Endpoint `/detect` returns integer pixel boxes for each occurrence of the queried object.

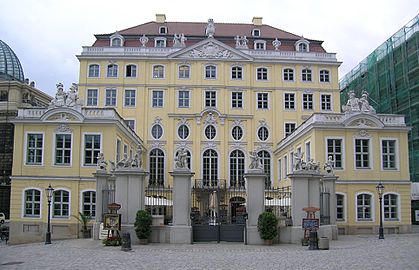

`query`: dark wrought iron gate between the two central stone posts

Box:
[191,179,246,242]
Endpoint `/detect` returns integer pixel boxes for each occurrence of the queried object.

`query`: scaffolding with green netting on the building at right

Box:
[339,15,419,182]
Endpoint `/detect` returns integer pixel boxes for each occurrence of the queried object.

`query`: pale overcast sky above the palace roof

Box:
[0,0,419,95]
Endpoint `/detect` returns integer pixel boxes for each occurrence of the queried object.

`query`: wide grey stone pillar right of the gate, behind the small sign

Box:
[288,170,322,244]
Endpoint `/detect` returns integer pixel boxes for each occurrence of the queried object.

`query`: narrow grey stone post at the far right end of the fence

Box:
[320,174,338,240]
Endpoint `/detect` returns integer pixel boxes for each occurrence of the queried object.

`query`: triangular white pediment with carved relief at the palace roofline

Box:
[169,38,252,60]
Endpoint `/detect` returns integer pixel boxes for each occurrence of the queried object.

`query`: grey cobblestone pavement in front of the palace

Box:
[0,234,419,270]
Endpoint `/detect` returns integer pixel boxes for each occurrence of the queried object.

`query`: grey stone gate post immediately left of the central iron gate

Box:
[170,170,195,244]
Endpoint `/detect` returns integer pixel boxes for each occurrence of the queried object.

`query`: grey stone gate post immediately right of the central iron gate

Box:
[244,169,266,245]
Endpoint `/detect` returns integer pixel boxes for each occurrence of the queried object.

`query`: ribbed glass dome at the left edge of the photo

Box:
[0,40,25,82]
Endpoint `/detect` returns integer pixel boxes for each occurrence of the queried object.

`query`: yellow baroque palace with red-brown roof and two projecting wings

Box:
[10,14,411,243]
